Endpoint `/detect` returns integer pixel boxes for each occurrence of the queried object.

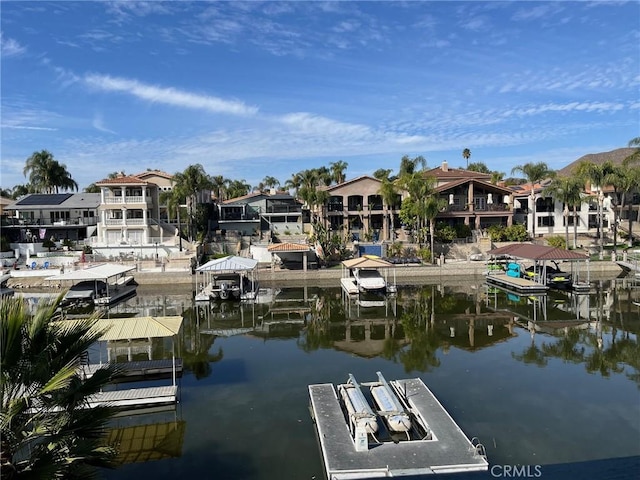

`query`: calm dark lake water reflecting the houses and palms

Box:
[47,280,640,480]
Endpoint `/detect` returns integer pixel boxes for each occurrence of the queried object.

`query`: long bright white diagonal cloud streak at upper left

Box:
[84,74,258,116]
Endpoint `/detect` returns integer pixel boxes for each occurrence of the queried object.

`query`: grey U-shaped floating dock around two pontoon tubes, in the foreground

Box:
[309,378,488,480]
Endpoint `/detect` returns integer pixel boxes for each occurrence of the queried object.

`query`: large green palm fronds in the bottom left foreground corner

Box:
[0,295,119,479]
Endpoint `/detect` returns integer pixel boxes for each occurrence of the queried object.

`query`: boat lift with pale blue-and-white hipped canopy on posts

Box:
[196,256,258,301]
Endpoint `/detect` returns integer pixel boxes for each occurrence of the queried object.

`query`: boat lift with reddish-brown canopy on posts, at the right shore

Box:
[487,243,590,292]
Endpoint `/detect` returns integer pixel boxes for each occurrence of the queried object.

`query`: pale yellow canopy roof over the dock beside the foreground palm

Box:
[95,315,182,341]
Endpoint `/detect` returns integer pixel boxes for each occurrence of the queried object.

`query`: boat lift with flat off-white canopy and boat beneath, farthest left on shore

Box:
[46,263,138,305]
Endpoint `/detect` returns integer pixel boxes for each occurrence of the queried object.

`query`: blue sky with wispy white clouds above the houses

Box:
[0,1,640,188]
